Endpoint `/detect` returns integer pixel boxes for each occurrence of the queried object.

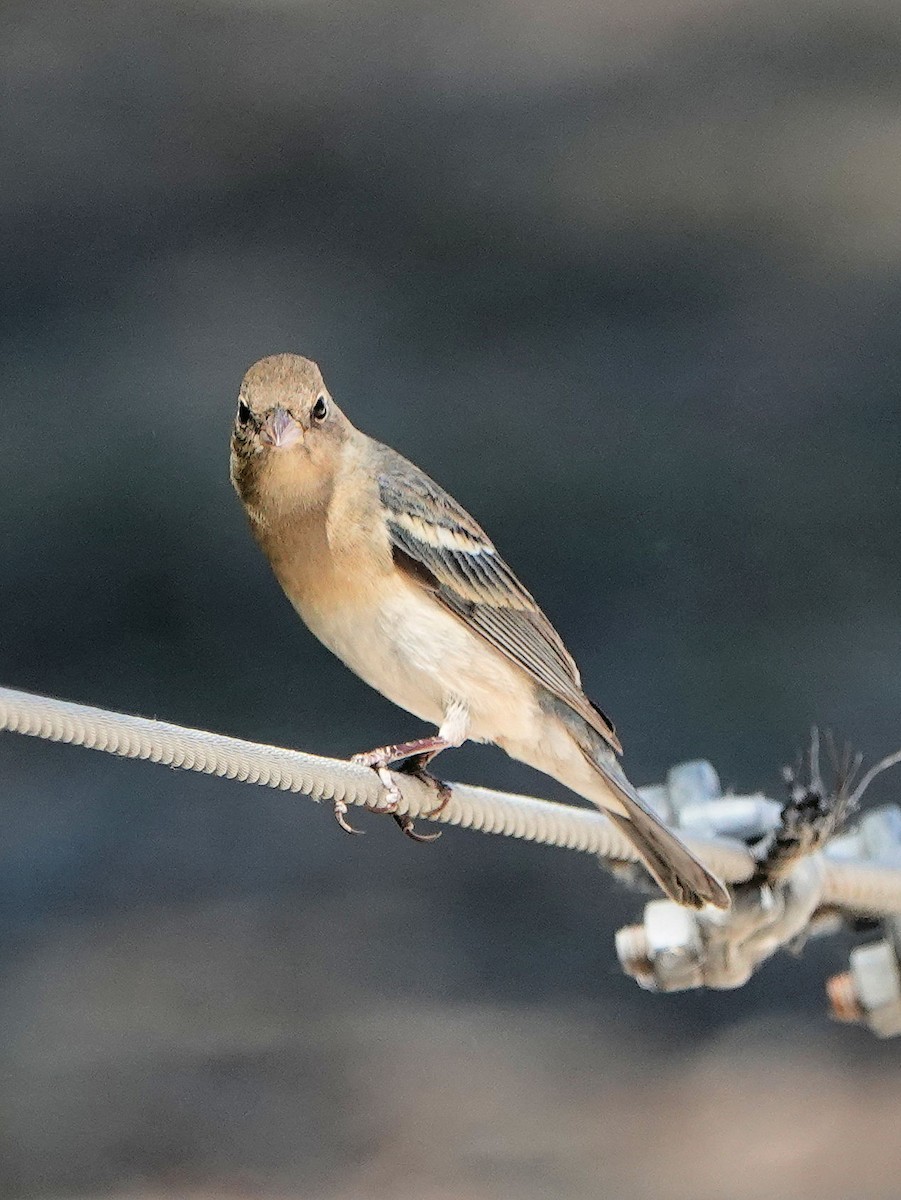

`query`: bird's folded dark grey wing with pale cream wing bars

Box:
[378,448,621,751]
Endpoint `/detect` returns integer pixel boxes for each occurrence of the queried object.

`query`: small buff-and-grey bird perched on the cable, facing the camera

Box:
[230,354,729,908]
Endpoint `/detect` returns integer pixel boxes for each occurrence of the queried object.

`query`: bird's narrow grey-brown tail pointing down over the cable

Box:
[579,739,729,908]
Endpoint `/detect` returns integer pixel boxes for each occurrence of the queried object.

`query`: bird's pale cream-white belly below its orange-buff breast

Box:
[293,583,537,742]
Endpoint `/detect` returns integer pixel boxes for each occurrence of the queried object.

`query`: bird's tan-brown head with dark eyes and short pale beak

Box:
[232,354,353,515]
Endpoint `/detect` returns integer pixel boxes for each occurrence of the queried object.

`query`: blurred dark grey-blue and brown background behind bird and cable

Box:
[0,0,901,1200]
